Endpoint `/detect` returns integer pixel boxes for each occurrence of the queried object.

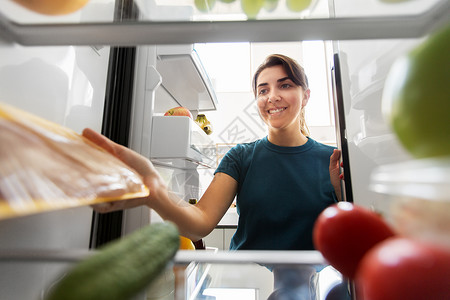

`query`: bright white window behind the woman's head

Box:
[195,41,335,144]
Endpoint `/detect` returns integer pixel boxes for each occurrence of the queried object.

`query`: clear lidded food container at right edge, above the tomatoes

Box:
[371,157,450,248]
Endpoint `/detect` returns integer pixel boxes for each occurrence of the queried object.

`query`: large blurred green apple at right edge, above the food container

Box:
[382,25,450,158]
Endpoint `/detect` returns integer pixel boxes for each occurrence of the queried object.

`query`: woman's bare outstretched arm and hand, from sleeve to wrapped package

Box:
[83,128,237,240]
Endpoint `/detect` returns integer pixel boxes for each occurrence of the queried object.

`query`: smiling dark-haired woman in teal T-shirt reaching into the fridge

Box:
[81,55,341,250]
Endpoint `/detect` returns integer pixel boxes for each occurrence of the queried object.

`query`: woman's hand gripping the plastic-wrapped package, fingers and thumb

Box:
[82,128,167,213]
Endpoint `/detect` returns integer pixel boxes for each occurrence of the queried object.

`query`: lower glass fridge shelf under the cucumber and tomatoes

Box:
[0,248,348,300]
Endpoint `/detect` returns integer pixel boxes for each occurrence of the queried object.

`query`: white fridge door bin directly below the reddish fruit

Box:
[150,116,215,169]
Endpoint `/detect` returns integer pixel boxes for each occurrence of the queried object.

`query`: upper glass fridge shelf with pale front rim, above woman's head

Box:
[0,0,450,46]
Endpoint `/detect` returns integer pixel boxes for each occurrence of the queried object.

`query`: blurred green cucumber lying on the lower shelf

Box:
[47,222,180,300]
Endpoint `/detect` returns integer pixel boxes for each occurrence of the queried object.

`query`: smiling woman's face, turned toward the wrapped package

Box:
[256,65,309,130]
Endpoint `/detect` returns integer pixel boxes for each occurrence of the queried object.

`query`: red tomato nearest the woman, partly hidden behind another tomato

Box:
[313,202,394,279]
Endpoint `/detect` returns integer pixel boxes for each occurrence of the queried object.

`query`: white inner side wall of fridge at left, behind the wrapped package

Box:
[0,40,109,299]
